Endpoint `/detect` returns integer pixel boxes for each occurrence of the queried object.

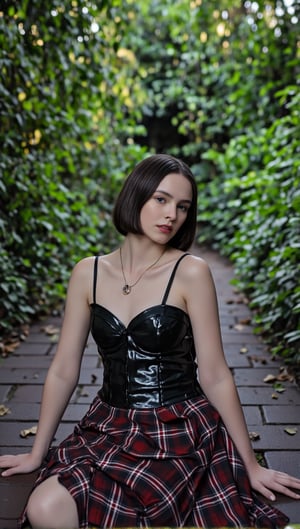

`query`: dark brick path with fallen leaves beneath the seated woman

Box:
[0,245,300,529]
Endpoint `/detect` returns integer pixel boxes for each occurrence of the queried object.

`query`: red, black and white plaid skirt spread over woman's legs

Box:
[20,396,288,529]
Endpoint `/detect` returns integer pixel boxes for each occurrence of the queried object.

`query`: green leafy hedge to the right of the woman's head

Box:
[200,87,300,361]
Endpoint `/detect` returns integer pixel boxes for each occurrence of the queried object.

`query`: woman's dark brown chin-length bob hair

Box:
[113,154,198,251]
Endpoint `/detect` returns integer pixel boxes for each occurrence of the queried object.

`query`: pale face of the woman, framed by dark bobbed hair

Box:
[140,173,192,244]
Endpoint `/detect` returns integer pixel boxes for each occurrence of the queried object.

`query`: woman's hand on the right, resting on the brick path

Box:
[249,464,300,501]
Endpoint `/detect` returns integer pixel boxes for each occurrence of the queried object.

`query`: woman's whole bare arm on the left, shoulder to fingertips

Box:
[0,259,93,476]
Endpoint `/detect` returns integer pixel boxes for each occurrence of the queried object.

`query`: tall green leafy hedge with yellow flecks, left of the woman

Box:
[0,0,143,333]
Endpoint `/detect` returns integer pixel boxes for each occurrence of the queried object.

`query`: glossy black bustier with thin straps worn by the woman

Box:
[91,254,202,408]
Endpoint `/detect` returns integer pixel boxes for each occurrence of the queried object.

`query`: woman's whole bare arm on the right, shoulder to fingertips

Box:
[186,257,300,500]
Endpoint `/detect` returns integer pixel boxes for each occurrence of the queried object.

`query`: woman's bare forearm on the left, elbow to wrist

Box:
[32,370,77,461]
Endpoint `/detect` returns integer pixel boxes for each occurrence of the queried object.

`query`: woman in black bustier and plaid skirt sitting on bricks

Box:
[0,154,300,529]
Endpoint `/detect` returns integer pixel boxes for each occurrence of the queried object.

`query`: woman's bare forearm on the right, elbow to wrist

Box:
[203,371,257,473]
